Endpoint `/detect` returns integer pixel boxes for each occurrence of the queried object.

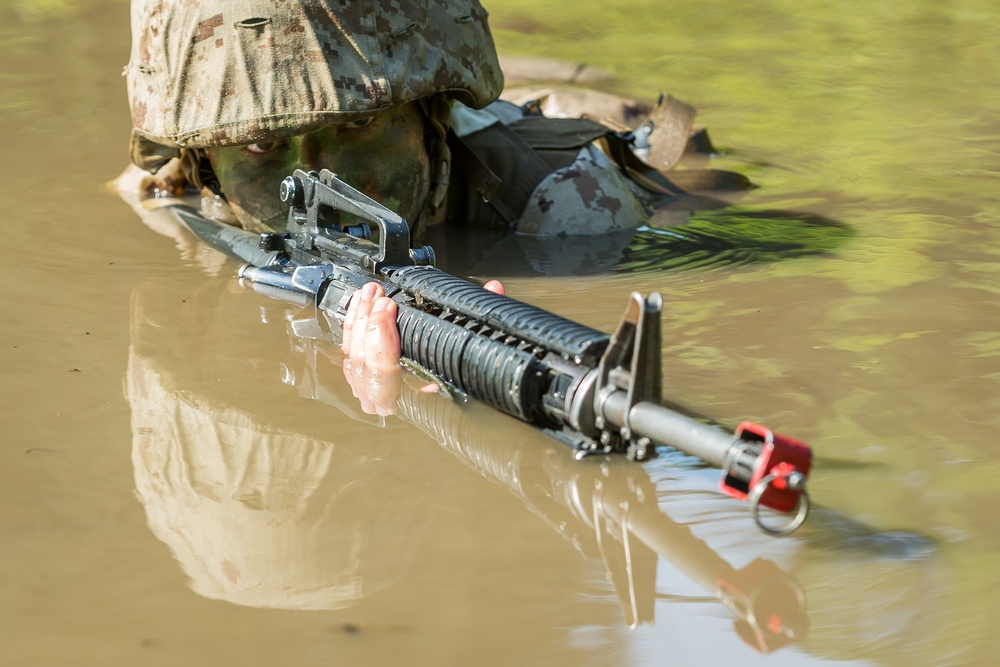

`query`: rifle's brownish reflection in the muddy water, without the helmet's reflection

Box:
[279,300,936,653]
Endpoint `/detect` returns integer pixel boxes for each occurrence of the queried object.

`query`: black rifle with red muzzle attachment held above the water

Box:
[240,170,811,534]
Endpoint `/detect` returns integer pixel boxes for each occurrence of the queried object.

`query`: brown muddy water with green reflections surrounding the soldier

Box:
[0,0,1000,665]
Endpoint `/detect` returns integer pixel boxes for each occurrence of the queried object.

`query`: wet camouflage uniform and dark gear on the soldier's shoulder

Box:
[447,102,750,236]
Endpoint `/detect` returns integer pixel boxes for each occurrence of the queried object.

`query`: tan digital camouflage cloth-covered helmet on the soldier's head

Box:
[126,0,503,170]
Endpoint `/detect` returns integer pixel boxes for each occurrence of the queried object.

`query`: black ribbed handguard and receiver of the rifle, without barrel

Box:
[242,240,610,451]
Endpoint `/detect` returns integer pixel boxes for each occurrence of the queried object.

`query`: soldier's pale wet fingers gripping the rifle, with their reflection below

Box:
[341,280,504,416]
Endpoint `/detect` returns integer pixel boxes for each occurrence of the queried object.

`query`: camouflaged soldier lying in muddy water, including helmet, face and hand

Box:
[126,0,744,402]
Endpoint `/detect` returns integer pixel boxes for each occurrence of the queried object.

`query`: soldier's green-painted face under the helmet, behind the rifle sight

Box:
[206,103,430,232]
